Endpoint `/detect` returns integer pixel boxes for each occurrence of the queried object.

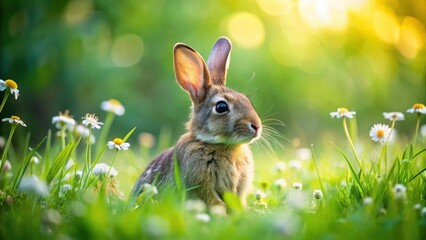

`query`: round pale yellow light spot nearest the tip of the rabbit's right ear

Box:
[227,12,265,48]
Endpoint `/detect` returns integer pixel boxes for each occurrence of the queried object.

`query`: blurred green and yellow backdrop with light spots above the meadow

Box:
[0,0,426,145]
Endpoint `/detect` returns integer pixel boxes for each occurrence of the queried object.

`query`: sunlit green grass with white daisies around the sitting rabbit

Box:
[0,79,426,239]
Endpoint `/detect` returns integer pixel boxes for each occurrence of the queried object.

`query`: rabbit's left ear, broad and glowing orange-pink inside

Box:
[173,43,211,102]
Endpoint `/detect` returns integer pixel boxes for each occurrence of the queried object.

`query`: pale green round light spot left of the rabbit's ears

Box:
[111,34,144,67]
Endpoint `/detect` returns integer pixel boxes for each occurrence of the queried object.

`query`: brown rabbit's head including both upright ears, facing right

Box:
[174,37,262,145]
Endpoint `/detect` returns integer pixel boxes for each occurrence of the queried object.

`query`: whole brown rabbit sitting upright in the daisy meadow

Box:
[132,37,262,206]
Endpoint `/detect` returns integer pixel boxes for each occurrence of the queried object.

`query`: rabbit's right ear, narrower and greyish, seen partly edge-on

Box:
[207,37,232,85]
